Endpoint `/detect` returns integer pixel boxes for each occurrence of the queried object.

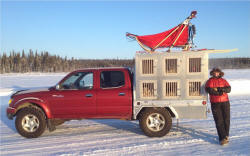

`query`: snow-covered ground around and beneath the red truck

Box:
[0,69,250,156]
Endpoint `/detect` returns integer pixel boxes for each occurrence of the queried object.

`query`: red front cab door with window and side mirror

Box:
[50,72,96,118]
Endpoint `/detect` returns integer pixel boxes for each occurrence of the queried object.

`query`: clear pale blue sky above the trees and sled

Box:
[0,0,250,59]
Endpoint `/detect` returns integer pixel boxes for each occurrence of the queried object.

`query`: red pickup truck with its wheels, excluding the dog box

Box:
[7,68,173,138]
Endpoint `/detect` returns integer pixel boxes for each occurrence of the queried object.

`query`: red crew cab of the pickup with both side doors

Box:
[48,68,133,119]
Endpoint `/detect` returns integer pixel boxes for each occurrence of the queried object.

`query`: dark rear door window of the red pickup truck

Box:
[100,71,125,88]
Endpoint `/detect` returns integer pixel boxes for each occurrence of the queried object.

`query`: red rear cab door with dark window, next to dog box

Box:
[97,70,132,118]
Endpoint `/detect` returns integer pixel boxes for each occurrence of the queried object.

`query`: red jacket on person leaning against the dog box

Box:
[206,77,231,103]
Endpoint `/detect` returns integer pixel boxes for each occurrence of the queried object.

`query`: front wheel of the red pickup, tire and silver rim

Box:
[15,107,46,138]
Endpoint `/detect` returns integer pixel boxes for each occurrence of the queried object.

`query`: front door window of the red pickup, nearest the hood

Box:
[60,72,93,89]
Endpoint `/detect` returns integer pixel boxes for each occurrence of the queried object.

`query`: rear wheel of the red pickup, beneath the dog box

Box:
[139,108,172,137]
